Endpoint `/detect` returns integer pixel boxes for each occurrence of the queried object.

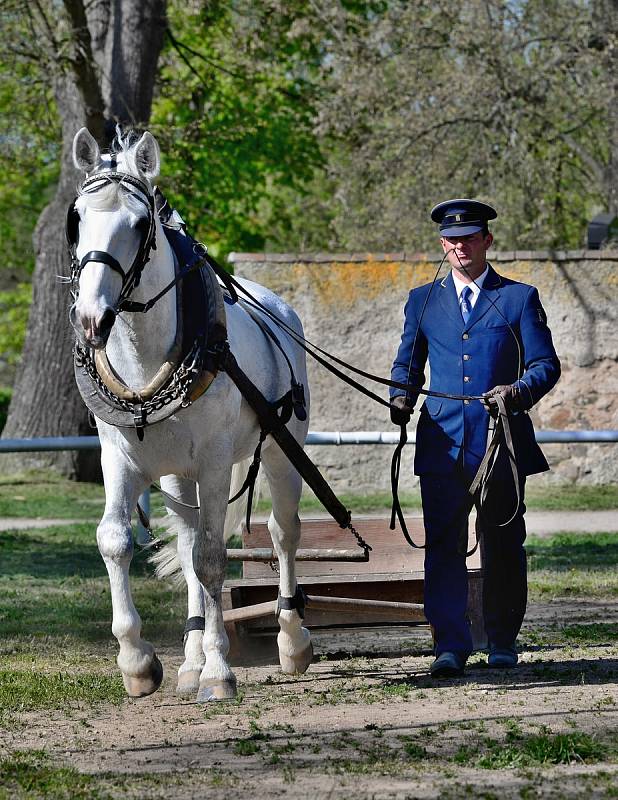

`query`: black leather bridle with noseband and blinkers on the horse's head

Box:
[66,172,156,311]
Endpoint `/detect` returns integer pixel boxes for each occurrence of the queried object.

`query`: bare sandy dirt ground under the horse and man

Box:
[0,601,618,800]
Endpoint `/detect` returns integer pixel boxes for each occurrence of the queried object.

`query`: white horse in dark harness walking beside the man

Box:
[70,128,312,702]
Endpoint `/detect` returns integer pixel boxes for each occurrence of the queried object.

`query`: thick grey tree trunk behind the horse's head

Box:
[2,0,165,480]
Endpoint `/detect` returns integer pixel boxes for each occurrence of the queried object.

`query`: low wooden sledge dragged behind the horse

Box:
[223,516,487,665]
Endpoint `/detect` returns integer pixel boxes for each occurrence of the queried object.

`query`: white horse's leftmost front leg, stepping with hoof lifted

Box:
[97,444,163,697]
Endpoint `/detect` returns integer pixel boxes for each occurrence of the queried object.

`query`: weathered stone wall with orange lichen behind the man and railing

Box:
[230,251,618,492]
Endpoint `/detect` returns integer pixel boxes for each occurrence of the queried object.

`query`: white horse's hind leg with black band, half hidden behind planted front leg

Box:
[161,475,204,697]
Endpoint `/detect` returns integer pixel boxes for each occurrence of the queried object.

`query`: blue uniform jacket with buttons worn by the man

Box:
[390,266,560,475]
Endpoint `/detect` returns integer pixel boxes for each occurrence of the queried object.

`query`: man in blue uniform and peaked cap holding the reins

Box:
[391,200,560,677]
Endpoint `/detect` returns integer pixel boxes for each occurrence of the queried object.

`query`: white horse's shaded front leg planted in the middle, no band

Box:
[193,453,236,703]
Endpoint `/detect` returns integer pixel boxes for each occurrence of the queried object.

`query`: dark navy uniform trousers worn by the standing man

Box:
[420,460,527,660]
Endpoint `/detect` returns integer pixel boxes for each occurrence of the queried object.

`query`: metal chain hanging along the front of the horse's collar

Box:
[75,340,202,416]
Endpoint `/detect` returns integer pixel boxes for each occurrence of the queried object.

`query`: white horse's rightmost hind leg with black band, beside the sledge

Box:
[263,443,313,674]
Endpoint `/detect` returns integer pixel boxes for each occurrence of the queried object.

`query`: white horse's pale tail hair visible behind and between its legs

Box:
[148,458,260,586]
